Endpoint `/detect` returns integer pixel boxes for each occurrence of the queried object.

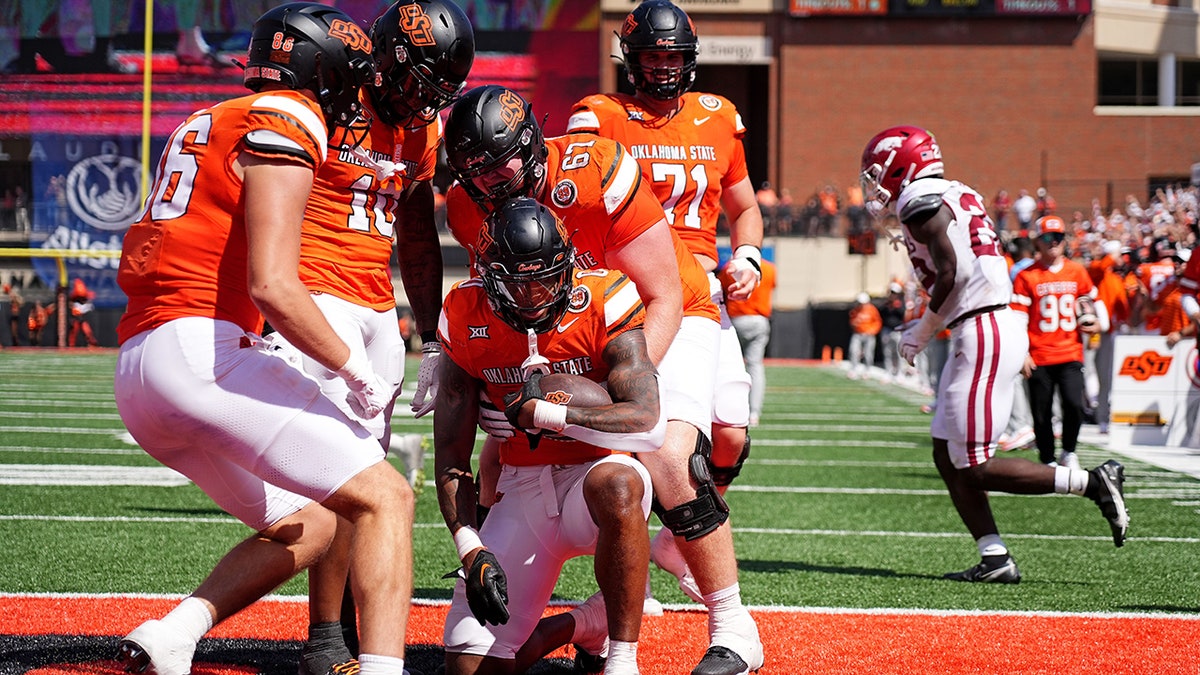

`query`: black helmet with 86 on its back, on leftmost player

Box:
[242,2,374,144]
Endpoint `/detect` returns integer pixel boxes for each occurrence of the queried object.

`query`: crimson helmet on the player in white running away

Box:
[860,126,944,217]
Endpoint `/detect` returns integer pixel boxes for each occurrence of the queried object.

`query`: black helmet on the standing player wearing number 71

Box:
[617,0,700,101]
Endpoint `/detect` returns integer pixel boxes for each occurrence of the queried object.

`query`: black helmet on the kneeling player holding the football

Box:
[475,197,575,333]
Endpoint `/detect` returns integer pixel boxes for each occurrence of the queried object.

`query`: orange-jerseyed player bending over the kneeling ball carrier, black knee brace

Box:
[445,85,762,674]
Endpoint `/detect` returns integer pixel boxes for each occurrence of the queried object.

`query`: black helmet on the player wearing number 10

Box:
[367,0,475,127]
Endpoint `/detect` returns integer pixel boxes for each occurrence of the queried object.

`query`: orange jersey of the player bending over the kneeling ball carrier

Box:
[446,133,720,321]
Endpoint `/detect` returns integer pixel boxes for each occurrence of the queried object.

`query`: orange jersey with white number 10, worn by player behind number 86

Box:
[300,94,442,311]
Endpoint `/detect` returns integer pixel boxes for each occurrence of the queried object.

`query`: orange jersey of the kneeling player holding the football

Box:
[438,269,646,466]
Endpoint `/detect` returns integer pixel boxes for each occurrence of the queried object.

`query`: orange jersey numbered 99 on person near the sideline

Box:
[1012,259,1096,365]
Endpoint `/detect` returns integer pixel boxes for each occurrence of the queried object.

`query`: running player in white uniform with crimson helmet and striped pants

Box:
[862,126,1129,584]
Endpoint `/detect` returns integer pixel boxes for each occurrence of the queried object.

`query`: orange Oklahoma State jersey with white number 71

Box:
[566,91,748,261]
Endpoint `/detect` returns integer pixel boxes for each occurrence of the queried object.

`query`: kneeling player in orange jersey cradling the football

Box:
[433,198,666,675]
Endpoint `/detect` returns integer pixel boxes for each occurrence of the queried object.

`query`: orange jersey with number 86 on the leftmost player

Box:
[116,91,328,342]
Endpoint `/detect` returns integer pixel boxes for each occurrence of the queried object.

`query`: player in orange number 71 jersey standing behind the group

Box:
[568,0,762,619]
